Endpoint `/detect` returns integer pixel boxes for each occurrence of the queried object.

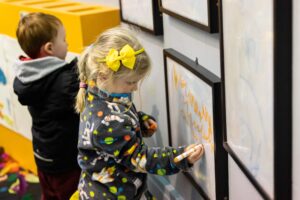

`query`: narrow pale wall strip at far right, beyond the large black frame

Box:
[293,0,300,200]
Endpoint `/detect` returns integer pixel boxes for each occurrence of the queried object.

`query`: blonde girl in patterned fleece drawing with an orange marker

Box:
[76,28,203,199]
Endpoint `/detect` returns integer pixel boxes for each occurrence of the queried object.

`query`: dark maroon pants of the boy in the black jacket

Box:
[38,169,81,200]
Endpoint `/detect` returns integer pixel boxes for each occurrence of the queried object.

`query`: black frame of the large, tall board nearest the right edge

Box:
[219,0,292,199]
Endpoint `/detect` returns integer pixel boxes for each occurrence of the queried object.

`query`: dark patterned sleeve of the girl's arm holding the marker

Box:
[92,108,189,175]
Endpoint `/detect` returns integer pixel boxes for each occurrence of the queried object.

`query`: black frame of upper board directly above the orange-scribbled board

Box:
[160,0,219,33]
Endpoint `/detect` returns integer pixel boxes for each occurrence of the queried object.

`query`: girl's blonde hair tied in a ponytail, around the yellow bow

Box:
[75,27,150,112]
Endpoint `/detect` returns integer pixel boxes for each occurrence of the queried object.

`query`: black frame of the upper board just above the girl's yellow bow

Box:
[119,0,163,35]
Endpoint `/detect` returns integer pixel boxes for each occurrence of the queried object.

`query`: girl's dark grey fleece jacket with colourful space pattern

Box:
[78,85,189,200]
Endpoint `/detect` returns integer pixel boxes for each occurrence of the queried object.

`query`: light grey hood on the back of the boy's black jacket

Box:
[13,56,67,84]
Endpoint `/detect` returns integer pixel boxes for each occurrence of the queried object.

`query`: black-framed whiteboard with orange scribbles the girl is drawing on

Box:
[164,49,227,199]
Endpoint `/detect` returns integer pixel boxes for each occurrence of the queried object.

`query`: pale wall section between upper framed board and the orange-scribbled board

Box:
[163,14,221,77]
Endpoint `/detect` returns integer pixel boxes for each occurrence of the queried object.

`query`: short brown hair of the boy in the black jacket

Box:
[16,12,62,59]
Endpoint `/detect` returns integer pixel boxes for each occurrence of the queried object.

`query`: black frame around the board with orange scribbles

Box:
[163,49,228,199]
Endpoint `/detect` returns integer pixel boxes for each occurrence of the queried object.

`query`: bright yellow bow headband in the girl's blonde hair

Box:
[99,44,144,72]
